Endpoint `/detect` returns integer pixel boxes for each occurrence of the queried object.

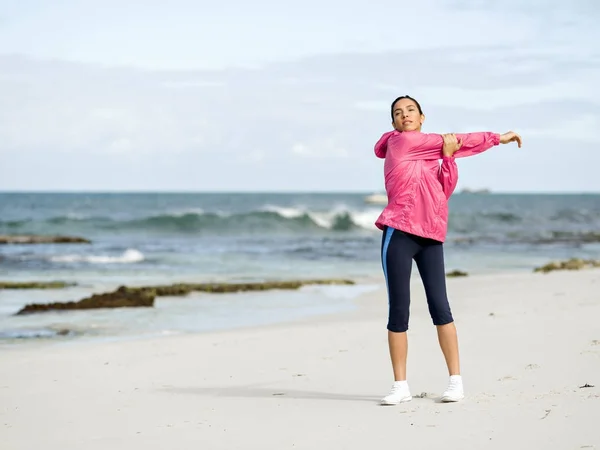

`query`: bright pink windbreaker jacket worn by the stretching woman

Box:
[375,130,500,242]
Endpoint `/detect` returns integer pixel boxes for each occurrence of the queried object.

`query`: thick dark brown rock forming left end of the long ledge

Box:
[17,286,155,315]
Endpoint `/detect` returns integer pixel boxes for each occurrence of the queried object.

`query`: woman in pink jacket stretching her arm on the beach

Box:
[375,96,521,405]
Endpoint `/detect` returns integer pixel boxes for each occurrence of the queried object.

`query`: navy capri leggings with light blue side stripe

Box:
[381,227,454,333]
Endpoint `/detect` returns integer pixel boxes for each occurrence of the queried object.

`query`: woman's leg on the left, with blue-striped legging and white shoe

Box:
[381,228,420,405]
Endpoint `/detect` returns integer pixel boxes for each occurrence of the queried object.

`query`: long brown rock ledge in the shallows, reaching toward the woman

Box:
[11,279,354,315]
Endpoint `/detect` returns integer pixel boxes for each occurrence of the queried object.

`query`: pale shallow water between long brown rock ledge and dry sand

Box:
[0,279,377,350]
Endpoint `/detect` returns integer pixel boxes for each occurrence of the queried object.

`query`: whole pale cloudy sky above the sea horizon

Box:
[0,0,600,192]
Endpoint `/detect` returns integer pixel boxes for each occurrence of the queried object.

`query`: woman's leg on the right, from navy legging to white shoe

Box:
[415,240,463,401]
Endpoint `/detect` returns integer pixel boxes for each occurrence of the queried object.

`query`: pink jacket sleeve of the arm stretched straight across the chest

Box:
[398,131,500,161]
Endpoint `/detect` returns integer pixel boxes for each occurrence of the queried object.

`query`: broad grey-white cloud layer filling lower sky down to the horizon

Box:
[0,32,600,191]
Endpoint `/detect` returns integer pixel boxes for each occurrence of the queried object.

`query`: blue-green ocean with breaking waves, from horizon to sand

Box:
[0,193,600,342]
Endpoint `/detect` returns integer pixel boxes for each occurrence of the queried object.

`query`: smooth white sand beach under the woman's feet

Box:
[0,270,600,450]
